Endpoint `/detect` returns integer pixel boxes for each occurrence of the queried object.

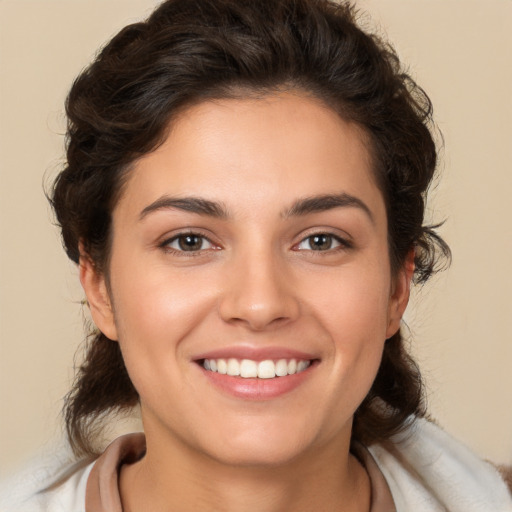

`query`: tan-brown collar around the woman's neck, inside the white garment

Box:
[85,433,396,512]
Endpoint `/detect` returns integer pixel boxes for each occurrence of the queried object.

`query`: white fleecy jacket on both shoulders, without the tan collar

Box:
[0,419,512,512]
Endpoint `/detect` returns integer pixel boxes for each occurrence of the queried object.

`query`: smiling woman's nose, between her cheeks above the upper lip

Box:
[219,250,300,331]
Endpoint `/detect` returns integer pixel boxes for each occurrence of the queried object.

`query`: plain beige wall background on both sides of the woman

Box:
[0,0,512,474]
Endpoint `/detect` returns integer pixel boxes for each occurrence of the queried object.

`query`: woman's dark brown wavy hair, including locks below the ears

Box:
[49,0,450,454]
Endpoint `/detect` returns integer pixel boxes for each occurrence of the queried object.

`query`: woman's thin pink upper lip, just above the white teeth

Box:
[192,345,318,361]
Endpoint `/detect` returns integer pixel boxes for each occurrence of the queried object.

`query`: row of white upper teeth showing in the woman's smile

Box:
[203,358,311,379]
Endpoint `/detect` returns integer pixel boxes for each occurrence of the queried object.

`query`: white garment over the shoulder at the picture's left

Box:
[0,443,94,512]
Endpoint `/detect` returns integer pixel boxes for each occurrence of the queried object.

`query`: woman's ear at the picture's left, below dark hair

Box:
[79,244,117,340]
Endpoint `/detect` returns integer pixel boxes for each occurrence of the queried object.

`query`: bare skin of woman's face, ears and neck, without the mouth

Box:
[80,92,412,512]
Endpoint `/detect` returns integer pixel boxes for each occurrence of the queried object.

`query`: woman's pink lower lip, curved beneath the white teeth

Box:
[199,361,317,400]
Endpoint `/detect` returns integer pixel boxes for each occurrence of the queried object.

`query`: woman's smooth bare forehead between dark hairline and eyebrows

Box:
[118,93,382,222]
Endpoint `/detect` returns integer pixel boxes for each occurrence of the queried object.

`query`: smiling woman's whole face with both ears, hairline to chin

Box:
[81,93,410,464]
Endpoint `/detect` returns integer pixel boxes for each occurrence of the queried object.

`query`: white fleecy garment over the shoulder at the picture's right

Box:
[369,419,512,512]
